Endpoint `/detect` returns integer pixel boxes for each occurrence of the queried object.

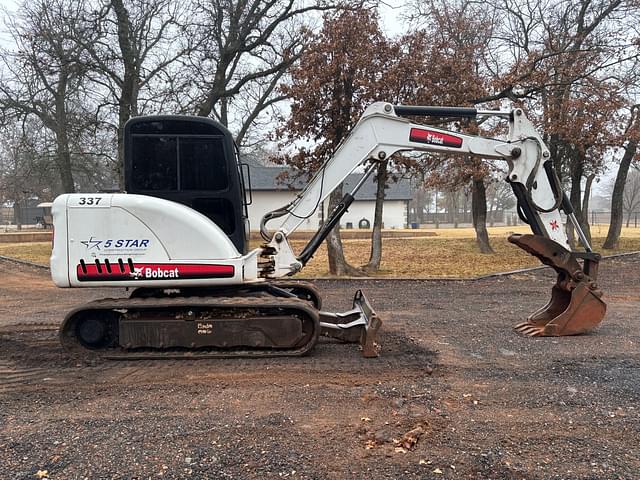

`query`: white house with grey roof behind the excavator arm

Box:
[249,165,411,230]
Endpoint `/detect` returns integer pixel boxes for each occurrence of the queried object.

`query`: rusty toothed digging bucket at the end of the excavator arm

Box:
[509,234,607,337]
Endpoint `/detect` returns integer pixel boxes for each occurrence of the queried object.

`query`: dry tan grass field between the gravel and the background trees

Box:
[0,225,640,278]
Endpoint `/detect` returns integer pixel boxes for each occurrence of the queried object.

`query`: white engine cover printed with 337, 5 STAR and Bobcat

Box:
[51,193,258,288]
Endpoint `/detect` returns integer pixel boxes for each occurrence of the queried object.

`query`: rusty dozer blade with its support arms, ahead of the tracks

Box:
[320,290,382,358]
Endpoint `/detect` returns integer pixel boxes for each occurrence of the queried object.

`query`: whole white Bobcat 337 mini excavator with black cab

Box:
[51,102,606,359]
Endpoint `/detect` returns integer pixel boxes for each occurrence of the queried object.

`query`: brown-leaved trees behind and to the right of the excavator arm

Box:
[280,0,640,274]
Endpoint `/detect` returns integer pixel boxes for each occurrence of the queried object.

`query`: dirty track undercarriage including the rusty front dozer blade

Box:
[60,282,381,359]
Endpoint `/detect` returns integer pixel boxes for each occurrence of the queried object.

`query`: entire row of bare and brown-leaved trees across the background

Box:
[0,0,640,274]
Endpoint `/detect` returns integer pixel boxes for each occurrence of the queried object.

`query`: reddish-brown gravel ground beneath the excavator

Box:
[0,256,640,479]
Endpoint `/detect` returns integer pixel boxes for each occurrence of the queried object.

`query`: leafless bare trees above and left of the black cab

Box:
[0,0,344,195]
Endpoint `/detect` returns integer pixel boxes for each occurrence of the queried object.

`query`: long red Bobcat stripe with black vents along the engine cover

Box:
[76,262,235,282]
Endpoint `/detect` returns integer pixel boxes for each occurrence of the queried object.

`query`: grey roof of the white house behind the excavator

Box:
[245,165,411,200]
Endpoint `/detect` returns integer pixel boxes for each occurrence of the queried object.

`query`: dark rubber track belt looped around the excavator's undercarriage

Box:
[60,297,320,360]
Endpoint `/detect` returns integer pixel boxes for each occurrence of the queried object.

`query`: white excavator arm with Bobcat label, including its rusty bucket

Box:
[261,102,605,335]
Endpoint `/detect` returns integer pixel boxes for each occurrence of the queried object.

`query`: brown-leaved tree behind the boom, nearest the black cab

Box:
[280,9,390,275]
